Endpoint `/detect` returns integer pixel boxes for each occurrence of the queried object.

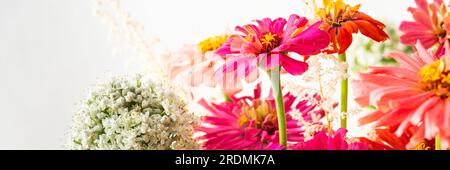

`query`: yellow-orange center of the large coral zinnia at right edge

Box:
[418,60,450,99]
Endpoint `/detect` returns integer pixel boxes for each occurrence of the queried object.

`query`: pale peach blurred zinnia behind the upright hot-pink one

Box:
[168,35,242,95]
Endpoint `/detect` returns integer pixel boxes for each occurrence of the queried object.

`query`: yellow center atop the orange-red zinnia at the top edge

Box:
[313,0,361,27]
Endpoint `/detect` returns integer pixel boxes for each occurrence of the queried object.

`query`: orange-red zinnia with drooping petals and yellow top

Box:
[314,0,389,54]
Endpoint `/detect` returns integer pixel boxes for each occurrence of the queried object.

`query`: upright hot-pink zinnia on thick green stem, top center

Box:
[216,15,329,82]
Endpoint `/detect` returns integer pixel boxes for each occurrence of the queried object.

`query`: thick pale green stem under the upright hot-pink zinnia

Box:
[268,67,287,147]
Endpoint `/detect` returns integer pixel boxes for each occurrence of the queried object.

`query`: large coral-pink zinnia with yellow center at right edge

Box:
[354,42,450,149]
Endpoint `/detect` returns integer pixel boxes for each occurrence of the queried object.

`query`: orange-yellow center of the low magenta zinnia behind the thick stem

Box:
[239,100,277,133]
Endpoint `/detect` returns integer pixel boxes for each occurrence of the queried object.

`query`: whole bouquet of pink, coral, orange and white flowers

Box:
[68,0,450,150]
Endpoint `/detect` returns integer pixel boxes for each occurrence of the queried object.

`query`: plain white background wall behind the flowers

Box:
[0,0,414,149]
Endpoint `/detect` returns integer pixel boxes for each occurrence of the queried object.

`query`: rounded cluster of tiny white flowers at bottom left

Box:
[68,76,199,150]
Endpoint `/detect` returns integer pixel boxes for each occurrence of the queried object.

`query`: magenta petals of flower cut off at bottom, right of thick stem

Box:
[291,128,369,150]
